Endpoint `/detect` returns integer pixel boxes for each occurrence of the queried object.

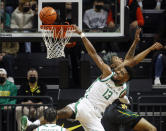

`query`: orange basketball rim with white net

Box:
[40,25,74,59]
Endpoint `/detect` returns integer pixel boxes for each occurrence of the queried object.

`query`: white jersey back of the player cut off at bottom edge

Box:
[36,124,66,131]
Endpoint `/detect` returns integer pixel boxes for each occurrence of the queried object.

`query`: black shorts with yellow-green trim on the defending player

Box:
[102,100,141,131]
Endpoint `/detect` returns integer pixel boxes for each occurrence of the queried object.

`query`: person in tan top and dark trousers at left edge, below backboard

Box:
[0,42,19,83]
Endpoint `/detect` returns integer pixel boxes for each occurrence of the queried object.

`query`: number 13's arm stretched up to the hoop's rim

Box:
[75,26,111,74]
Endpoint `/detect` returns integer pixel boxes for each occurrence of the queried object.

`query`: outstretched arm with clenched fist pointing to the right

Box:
[116,42,163,69]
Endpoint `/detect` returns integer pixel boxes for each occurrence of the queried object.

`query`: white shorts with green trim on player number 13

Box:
[68,98,104,131]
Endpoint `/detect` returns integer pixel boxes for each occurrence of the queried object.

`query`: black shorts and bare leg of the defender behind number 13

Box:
[102,99,157,131]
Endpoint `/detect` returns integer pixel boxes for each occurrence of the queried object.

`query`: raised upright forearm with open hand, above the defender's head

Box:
[125,28,141,60]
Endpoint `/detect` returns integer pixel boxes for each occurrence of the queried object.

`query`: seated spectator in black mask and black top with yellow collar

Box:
[16,68,47,131]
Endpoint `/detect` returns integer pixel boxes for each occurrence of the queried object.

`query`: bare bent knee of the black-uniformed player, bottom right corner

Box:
[133,118,157,131]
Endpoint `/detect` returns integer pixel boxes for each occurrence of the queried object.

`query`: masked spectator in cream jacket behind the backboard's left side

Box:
[10,0,35,53]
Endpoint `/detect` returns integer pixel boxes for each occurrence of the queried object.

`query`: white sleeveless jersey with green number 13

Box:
[85,73,127,113]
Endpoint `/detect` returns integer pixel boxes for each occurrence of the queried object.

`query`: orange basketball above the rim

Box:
[39,7,57,25]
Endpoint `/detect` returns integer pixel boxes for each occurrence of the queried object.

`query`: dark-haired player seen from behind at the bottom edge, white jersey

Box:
[22,107,69,131]
